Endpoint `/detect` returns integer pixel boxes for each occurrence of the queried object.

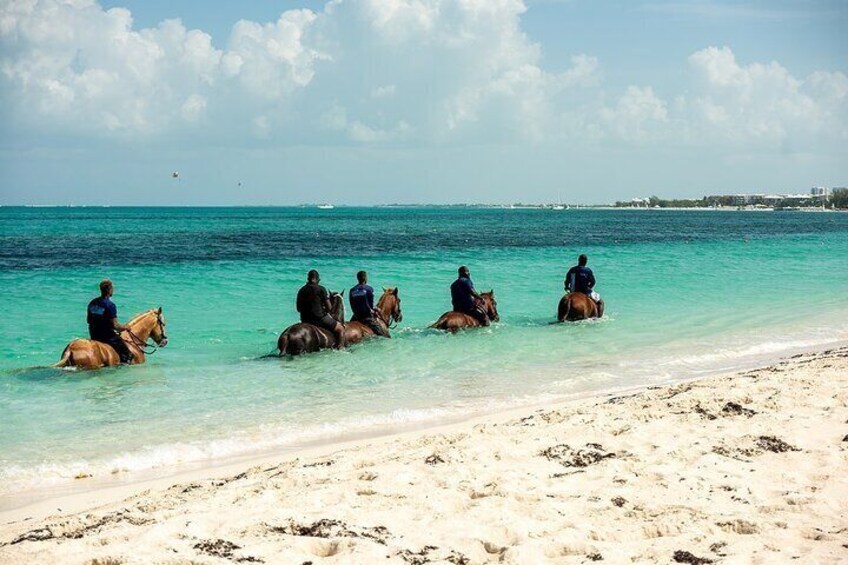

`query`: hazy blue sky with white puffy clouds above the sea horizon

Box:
[0,0,848,206]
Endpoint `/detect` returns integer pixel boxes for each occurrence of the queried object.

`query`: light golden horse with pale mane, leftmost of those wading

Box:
[53,306,168,369]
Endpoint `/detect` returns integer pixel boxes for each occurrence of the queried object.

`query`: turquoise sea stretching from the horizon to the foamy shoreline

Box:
[0,208,848,498]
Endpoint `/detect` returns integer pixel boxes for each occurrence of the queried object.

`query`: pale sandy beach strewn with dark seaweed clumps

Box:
[0,348,848,565]
